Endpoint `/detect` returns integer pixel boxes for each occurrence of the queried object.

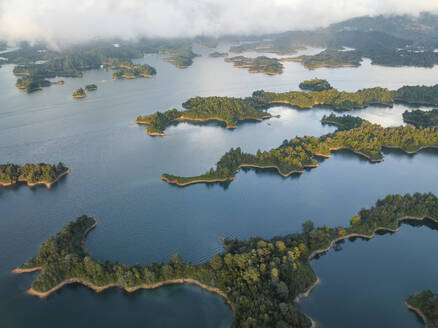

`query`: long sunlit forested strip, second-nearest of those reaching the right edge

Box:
[139,79,438,136]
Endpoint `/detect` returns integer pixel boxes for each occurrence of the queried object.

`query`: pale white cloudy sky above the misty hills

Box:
[0,0,438,43]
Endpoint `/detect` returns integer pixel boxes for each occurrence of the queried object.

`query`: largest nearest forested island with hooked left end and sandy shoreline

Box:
[13,193,438,328]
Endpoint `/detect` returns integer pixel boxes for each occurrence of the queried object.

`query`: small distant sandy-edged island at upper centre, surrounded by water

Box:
[224,56,284,75]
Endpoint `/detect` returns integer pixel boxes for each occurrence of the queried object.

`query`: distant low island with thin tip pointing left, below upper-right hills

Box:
[283,49,362,69]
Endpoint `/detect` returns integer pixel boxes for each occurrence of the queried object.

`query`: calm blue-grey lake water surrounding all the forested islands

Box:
[0,45,438,328]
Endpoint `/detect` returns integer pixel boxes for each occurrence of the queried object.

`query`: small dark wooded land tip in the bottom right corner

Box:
[405,290,438,328]
